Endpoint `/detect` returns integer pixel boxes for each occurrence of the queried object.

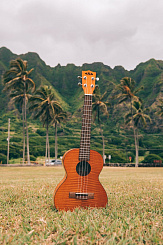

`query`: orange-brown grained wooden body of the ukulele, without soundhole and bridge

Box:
[54,149,107,211]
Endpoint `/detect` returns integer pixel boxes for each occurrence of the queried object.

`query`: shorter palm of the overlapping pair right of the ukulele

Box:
[125,101,151,167]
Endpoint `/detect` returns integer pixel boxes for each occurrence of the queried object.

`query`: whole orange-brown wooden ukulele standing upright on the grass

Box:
[54,71,107,211]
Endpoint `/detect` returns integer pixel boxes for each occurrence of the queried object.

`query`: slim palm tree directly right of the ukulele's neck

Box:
[92,88,110,162]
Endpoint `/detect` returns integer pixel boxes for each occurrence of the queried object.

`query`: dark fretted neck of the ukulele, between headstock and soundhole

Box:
[79,95,92,161]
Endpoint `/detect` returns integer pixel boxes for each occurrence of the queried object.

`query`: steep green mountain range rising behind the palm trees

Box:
[0,47,163,164]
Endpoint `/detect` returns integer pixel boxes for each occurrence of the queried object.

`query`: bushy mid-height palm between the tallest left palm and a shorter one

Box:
[29,86,62,163]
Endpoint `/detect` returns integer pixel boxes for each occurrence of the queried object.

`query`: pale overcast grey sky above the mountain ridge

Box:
[0,0,163,70]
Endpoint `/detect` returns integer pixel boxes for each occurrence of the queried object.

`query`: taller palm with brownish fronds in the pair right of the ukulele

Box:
[117,77,143,167]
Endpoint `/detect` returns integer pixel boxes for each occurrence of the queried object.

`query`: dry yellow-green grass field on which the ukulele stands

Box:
[0,167,163,244]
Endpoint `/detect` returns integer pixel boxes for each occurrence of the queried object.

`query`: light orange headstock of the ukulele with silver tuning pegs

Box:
[78,71,99,95]
